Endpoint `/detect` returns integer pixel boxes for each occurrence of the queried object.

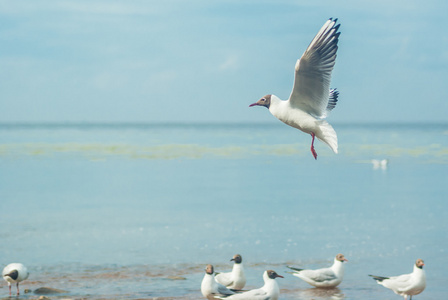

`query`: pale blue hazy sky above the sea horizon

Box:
[0,0,448,123]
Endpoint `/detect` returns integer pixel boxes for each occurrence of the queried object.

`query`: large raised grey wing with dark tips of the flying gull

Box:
[289,19,341,118]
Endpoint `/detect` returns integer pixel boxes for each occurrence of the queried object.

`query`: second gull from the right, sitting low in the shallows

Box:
[288,254,348,288]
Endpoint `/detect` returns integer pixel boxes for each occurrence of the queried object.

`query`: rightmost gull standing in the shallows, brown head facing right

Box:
[369,259,426,300]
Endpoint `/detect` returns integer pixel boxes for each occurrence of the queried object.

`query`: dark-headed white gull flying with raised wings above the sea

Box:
[249,19,341,159]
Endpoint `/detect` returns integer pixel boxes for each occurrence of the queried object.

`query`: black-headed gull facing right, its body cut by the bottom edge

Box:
[215,270,283,300]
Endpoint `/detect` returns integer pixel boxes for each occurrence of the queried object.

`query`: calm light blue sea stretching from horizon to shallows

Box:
[0,124,448,300]
